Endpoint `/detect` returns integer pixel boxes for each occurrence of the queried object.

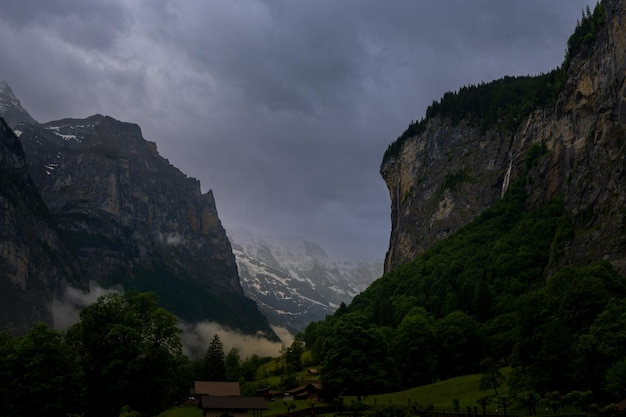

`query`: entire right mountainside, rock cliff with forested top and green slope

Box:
[305,0,626,400]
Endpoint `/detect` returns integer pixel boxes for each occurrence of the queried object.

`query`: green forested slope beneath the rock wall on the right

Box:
[304,141,626,404]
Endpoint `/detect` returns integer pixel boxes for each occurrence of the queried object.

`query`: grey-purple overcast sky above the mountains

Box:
[0,0,595,259]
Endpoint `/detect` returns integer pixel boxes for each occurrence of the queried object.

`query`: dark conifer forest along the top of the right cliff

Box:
[383,3,604,163]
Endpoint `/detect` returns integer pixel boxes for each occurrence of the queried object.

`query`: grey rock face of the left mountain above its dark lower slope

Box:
[18,115,242,294]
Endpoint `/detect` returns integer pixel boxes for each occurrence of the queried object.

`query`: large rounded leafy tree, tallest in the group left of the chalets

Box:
[68,293,185,416]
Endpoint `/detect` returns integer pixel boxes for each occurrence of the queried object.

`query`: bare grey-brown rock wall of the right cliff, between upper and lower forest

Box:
[381,0,626,273]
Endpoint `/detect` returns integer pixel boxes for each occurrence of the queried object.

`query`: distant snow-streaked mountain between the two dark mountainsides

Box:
[227,228,383,332]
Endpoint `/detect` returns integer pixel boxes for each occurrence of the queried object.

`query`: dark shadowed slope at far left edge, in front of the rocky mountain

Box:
[0,119,87,334]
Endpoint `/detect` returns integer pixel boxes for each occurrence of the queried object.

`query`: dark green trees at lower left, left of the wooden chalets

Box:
[0,292,276,417]
